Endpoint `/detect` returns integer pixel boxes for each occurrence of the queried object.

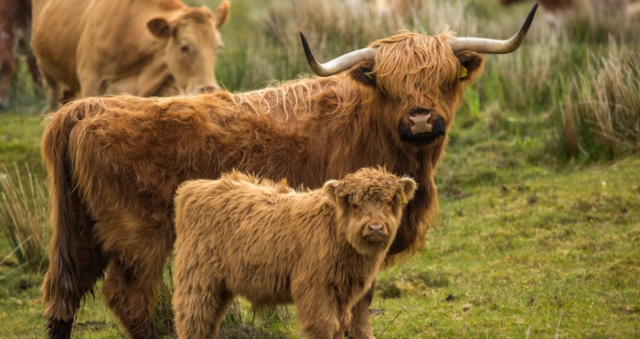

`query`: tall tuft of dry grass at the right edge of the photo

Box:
[561,40,640,159]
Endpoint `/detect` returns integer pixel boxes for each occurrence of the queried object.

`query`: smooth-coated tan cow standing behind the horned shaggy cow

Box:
[31,0,229,110]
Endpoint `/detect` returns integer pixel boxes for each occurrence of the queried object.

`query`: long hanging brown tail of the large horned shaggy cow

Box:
[41,101,86,321]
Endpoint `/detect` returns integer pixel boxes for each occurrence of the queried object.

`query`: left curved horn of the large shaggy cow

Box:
[300,32,376,77]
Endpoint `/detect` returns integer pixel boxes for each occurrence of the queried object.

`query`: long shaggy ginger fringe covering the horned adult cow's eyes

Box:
[369,31,459,107]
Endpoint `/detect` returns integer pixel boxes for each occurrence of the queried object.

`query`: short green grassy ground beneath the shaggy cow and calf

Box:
[0,143,640,338]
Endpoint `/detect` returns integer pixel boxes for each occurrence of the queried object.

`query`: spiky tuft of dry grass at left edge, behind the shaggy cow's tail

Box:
[0,164,51,273]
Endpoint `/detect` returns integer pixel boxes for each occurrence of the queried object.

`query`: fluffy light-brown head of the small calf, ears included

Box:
[324,169,416,255]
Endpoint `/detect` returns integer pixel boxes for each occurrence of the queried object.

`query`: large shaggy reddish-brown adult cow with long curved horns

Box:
[42,7,534,338]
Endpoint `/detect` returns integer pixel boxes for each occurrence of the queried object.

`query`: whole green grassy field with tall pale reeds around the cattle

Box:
[0,0,640,338]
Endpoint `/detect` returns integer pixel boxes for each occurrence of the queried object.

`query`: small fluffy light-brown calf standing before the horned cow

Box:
[173,168,416,339]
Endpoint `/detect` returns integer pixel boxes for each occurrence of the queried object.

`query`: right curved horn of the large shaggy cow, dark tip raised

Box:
[448,4,538,54]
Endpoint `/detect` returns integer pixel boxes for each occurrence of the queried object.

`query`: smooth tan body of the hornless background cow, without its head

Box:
[31,0,185,94]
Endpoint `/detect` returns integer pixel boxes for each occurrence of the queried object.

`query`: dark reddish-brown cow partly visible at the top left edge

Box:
[0,0,42,108]
